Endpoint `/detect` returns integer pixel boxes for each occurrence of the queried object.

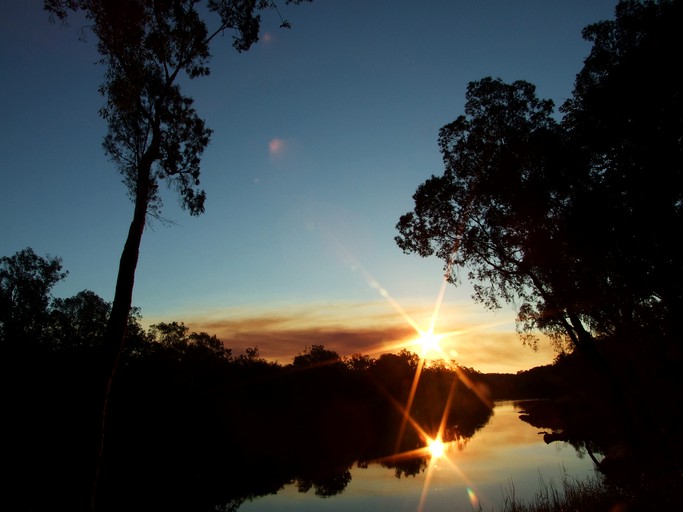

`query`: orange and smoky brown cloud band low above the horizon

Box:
[186,301,554,373]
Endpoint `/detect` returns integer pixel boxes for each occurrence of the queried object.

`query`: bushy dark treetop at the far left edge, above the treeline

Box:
[0,247,67,347]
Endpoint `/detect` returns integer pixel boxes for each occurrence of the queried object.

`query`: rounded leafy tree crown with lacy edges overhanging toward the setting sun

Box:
[396,78,585,345]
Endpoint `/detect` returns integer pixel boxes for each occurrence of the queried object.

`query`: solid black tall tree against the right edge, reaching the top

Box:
[561,0,683,346]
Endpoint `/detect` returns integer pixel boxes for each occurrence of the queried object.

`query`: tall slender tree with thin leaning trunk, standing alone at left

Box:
[44,0,310,508]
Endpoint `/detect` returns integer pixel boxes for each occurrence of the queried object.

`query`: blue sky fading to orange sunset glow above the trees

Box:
[0,0,616,372]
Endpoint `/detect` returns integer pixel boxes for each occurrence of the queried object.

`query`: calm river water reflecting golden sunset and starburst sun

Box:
[239,401,594,512]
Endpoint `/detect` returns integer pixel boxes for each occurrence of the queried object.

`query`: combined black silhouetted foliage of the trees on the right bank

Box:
[396,1,683,358]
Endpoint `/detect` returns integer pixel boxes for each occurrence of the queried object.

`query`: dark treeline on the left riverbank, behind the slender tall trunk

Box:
[0,249,491,511]
